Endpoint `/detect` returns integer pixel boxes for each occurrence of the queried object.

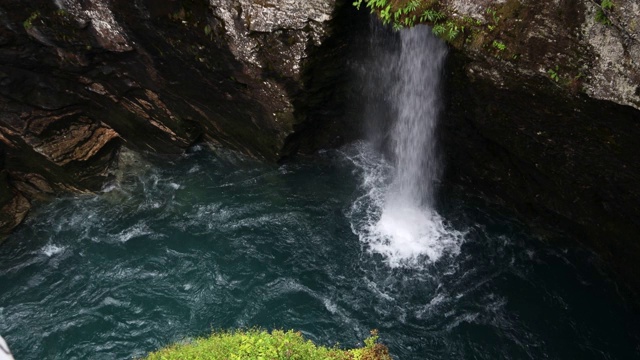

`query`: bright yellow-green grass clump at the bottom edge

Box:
[145,329,391,360]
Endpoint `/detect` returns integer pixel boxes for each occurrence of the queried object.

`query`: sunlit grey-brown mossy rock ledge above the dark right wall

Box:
[440,0,640,109]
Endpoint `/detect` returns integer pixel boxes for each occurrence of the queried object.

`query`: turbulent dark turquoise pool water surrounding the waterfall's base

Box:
[0,144,640,359]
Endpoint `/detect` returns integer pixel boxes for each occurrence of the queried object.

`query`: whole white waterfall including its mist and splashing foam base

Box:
[352,26,462,266]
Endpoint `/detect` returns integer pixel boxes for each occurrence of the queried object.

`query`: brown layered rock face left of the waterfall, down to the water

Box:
[0,0,344,238]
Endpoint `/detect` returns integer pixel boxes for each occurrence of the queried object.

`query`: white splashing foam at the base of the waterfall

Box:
[345,142,464,268]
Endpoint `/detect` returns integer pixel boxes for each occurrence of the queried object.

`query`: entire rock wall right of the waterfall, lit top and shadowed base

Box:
[442,0,640,301]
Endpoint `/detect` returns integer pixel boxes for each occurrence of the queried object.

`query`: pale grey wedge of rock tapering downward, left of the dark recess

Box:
[209,0,336,148]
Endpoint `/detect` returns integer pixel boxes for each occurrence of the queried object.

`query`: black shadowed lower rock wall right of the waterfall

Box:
[441,51,640,295]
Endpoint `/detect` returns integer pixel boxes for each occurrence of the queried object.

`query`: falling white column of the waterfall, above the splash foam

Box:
[387,27,446,208]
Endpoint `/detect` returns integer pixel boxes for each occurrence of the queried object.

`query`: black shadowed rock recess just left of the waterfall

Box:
[282,3,371,160]
